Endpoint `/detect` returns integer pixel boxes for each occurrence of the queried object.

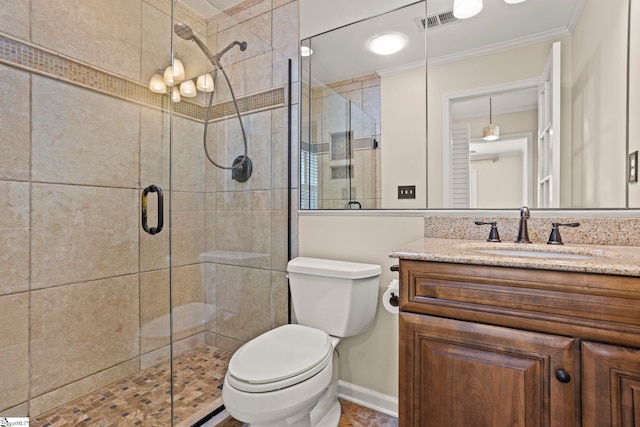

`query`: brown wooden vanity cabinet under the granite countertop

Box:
[399,259,640,427]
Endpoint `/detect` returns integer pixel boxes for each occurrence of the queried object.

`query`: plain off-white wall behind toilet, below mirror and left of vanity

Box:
[298,216,424,397]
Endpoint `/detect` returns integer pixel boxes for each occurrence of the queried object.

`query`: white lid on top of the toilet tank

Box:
[287,257,382,279]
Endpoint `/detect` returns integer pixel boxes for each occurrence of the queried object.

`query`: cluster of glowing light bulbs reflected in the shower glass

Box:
[149,58,214,102]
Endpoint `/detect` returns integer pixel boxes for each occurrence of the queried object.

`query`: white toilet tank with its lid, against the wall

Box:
[287,257,382,338]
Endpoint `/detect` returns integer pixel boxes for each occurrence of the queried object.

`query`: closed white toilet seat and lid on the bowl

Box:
[226,325,333,393]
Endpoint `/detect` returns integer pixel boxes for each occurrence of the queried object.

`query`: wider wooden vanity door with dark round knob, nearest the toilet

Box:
[399,313,577,427]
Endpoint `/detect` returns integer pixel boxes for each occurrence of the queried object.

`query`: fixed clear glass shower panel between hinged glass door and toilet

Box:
[170,0,298,426]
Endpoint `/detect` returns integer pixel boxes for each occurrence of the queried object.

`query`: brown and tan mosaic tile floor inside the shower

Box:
[30,345,231,427]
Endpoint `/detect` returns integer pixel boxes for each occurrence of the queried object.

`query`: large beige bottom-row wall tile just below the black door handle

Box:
[30,275,139,396]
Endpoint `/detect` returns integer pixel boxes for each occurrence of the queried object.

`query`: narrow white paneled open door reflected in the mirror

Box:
[538,42,561,208]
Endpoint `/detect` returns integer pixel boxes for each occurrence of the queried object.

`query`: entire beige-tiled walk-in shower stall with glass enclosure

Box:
[0,0,298,426]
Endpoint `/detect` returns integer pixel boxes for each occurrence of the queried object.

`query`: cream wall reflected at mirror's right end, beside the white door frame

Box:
[571,0,637,208]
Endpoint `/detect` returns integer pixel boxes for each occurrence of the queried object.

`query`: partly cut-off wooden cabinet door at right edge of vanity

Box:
[582,342,640,427]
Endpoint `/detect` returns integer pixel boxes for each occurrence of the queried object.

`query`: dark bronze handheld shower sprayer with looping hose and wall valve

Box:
[173,22,253,182]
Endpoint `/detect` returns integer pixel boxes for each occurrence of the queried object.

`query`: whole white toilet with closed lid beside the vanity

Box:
[222,257,382,427]
